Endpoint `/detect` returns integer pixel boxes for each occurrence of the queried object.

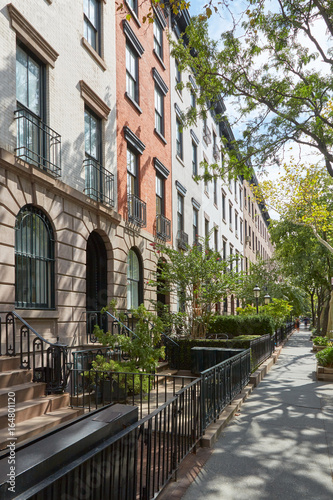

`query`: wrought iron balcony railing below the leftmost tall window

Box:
[15,108,61,177]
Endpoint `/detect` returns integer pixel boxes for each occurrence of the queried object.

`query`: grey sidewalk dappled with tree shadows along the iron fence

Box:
[162,327,333,500]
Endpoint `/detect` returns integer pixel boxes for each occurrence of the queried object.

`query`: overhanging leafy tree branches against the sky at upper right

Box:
[173,0,333,176]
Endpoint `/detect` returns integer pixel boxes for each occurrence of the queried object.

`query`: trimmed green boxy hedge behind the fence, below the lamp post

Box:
[208,314,274,338]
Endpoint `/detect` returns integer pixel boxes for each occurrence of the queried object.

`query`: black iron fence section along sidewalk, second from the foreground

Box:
[201,349,251,432]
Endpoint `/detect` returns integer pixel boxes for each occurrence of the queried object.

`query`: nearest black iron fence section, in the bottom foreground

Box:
[25,379,201,500]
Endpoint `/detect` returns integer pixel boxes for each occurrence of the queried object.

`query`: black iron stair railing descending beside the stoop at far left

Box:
[0,311,69,393]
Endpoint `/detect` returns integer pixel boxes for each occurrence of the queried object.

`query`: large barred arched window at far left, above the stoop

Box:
[15,205,54,309]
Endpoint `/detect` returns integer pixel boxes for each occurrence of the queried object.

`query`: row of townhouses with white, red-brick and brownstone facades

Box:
[0,0,270,360]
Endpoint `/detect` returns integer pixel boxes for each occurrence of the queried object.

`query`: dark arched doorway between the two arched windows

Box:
[86,231,108,334]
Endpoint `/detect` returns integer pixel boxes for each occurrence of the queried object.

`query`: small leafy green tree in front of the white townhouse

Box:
[149,237,239,338]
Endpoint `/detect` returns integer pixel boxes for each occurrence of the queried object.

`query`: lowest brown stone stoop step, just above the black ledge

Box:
[0,408,83,450]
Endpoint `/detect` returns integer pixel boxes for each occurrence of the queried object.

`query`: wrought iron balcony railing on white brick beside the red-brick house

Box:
[83,158,114,207]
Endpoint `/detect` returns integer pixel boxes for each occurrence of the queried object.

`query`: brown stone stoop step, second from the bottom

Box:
[0,393,69,429]
